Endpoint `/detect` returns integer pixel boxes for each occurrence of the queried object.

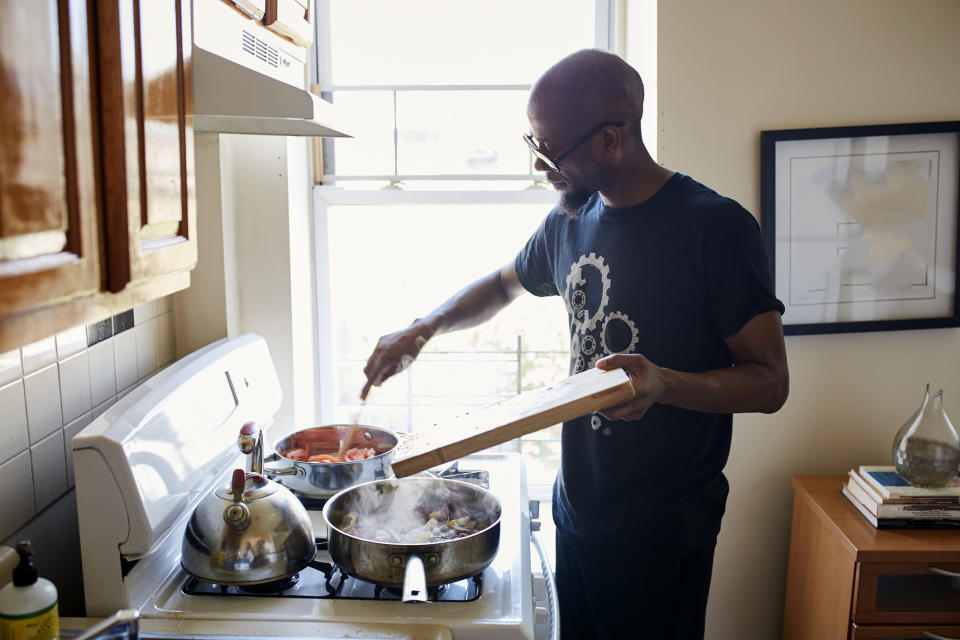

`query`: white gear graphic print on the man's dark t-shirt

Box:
[563,253,640,436]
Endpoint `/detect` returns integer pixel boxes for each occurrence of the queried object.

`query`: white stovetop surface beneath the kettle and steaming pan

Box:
[125,454,534,640]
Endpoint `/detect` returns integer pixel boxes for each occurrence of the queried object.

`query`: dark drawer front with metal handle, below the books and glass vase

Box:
[853,562,960,625]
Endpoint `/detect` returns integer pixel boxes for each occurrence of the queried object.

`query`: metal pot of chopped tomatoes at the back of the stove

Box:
[254,425,399,499]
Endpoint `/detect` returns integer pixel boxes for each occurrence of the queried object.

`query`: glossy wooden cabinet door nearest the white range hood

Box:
[95,0,197,292]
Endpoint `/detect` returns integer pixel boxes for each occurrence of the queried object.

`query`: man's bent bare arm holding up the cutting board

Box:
[597,311,790,420]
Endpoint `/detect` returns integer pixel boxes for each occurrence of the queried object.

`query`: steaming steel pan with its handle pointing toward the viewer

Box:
[323,477,501,602]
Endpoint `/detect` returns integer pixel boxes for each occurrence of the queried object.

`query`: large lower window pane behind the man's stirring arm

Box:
[328,205,569,436]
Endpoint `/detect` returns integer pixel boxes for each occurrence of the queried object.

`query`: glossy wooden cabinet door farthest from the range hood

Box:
[0,0,100,317]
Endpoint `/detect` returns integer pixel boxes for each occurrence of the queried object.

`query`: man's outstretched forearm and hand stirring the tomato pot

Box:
[360,262,524,399]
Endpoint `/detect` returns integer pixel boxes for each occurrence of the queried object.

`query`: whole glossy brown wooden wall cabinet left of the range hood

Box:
[0,0,197,351]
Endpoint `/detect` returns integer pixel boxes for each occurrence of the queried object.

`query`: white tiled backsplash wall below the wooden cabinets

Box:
[0,298,175,615]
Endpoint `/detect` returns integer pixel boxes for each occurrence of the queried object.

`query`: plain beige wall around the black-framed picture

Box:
[657,0,960,640]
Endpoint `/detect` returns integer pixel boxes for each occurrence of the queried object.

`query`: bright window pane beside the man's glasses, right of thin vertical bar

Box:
[397,91,530,175]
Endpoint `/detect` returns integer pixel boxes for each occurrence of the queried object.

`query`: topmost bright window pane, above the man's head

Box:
[330,0,595,85]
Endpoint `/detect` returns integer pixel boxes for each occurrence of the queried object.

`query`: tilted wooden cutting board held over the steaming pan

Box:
[392,369,633,478]
